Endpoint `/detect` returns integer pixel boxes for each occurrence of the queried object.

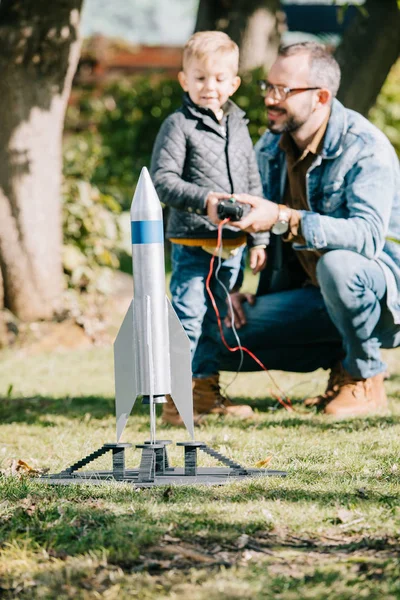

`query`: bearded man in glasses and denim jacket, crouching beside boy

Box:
[216,42,400,417]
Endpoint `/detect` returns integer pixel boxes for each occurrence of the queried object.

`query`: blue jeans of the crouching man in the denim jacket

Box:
[221,250,400,378]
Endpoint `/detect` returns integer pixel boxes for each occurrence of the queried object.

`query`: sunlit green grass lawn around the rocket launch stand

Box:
[0,340,400,600]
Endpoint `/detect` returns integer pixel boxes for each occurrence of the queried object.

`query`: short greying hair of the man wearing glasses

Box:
[278,42,340,97]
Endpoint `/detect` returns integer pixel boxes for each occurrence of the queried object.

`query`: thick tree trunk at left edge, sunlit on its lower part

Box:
[0,0,83,320]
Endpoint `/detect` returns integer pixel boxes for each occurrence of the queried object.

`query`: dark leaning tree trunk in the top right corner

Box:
[336,0,400,115]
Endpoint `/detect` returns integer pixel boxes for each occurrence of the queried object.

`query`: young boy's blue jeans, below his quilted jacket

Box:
[170,244,243,377]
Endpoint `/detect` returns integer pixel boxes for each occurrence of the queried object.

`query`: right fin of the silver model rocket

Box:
[166,297,194,439]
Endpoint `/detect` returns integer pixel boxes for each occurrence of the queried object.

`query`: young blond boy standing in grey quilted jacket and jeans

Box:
[151,31,268,425]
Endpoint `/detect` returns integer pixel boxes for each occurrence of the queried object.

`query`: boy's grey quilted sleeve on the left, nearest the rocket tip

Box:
[150,113,211,215]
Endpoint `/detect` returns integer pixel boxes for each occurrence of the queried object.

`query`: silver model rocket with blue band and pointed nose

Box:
[114,168,193,442]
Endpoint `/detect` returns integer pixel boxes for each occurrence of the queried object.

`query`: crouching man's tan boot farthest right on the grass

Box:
[324,370,387,417]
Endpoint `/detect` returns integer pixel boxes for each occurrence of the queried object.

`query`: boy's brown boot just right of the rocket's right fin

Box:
[193,374,254,419]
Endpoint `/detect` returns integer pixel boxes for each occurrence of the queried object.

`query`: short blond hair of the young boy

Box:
[183,31,239,74]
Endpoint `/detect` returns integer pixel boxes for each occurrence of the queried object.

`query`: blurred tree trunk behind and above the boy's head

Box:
[195,0,284,72]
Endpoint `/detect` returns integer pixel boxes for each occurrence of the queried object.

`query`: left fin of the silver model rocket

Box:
[114,300,139,442]
